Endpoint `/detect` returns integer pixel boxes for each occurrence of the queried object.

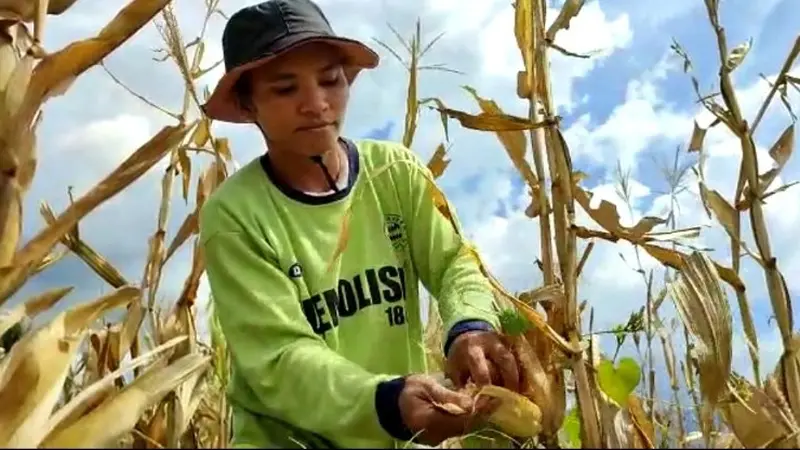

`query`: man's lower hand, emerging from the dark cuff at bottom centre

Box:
[400,374,497,446]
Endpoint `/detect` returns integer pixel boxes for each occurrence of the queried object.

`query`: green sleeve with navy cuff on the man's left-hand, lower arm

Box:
[201,206,410,445]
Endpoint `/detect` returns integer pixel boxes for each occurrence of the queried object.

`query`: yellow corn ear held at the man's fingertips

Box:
[478,385,542,438]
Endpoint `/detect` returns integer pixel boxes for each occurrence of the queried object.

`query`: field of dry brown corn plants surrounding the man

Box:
[0,0,800,448]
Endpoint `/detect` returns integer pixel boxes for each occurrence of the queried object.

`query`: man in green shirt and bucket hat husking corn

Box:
[200,0,520,448]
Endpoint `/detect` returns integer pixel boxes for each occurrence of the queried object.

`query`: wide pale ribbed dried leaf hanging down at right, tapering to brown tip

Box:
[668,252,733,407]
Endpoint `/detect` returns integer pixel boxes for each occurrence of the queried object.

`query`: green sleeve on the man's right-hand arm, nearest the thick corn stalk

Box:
[396,150,500,344]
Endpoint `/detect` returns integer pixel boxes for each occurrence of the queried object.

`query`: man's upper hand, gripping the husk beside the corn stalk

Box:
[445,330,522,392]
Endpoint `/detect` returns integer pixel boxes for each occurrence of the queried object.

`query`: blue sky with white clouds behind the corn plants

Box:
[7,0,800,406]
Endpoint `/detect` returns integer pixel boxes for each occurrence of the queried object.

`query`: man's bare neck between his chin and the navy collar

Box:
[269,138,346,192]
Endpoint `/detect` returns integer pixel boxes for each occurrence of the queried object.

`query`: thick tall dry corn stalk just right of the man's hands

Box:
[516,0,602,442]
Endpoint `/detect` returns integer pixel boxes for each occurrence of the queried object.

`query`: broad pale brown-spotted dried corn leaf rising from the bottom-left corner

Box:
[0,287,139,448]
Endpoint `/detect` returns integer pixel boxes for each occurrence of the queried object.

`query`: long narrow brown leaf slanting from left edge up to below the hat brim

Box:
[0,124,189,306]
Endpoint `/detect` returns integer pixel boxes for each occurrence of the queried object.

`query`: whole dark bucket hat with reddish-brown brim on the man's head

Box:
[203,0,380,123]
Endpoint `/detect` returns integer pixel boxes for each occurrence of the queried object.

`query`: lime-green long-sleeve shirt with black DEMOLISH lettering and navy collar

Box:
[200,139,498,448]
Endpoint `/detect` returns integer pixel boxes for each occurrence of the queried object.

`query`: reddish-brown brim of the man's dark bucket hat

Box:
[202,34,379,123]
